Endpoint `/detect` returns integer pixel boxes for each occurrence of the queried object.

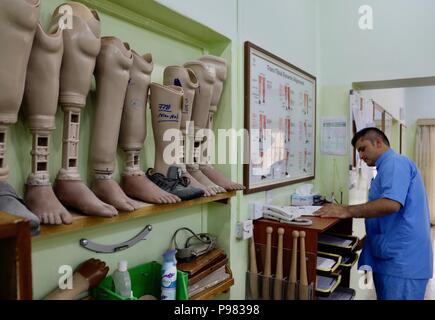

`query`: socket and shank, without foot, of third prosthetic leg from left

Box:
[51,2,101,180]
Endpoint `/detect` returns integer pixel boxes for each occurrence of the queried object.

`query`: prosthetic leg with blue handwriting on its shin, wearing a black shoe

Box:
[147,83,204,200]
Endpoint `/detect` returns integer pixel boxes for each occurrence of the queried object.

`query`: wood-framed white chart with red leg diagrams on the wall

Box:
[243,41,316,194]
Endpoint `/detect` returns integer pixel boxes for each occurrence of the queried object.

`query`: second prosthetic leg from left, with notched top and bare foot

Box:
[24,24,72,224]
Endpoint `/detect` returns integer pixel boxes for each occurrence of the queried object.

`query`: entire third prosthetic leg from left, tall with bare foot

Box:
[51,2,118,217]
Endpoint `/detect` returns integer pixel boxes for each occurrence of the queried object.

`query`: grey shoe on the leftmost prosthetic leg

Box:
[0,181,40,236]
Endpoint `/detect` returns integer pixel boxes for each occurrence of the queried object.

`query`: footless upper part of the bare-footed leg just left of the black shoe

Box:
[119,50,154,176]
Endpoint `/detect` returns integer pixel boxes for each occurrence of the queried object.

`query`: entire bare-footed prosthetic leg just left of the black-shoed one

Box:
[119,51,181,203]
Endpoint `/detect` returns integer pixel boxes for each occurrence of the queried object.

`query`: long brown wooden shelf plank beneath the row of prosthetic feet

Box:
[32,191,236,239]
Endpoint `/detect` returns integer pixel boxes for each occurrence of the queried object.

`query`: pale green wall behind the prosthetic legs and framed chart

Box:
[23,0,435,299]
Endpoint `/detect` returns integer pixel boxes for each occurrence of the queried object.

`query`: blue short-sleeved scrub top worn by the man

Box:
[358,149,433,279]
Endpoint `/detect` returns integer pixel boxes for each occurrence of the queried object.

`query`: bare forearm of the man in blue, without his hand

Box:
[347,199,400,218]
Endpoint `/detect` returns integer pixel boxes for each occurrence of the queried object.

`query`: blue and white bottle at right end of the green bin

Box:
[161,249,177,300]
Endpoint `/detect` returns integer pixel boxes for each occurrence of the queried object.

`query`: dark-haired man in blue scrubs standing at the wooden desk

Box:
[316,128,433,300]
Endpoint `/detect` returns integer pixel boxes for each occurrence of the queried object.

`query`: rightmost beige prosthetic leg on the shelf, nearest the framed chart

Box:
[199,55,244,190]
